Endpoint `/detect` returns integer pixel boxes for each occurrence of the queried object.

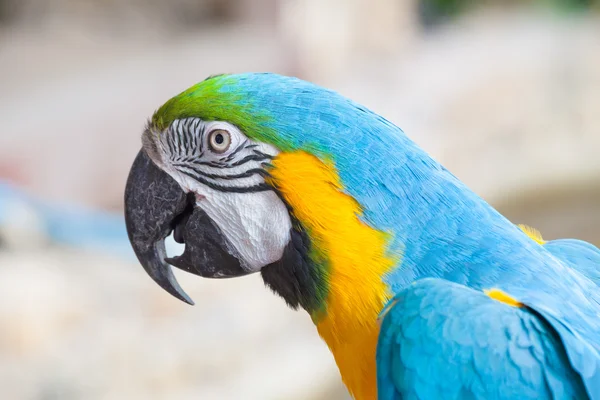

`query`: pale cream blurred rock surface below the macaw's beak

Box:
[0,249,345,400]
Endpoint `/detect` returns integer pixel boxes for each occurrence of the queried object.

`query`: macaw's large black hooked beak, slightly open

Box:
[125,150,250,305]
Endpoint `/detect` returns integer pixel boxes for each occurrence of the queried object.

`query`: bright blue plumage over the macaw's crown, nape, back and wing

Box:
[221,74,600,400]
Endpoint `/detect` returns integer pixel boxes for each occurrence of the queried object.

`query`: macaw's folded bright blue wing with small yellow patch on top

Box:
[377,278,600,400]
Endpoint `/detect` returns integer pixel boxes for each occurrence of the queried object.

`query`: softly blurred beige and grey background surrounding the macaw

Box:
[0,0,600,400]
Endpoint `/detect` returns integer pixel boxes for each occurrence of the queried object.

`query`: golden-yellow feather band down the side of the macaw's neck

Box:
[271,152,397,400]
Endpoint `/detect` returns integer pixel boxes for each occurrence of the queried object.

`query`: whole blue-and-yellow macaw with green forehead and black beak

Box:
[125,73,600,400]
